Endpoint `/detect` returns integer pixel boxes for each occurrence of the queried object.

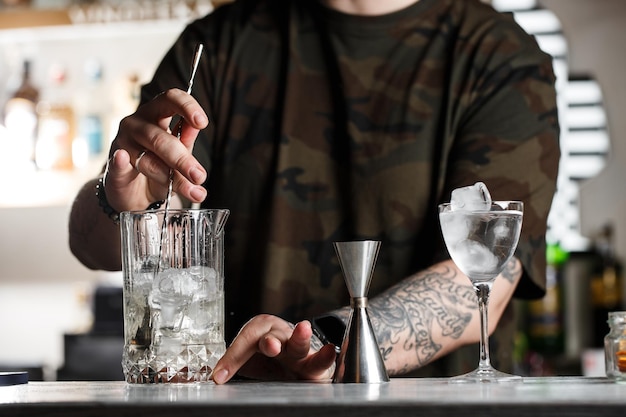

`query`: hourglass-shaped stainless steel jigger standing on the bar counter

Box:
[333,241,389,384]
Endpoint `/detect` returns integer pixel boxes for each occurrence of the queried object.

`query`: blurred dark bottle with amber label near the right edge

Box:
[590,224,623,348]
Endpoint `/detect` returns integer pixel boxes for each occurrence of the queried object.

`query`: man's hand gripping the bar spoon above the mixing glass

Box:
[104,89,208,212]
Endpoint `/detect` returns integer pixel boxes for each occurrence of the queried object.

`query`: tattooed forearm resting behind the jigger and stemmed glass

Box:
[324,258,522,375]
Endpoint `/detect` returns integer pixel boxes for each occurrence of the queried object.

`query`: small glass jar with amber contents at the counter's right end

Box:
[604,311,626,382]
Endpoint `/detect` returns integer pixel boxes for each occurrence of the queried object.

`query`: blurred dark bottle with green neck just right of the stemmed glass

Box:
[528,243,567,356]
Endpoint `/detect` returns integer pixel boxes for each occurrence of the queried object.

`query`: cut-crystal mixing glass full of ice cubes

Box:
[121,210,228,383]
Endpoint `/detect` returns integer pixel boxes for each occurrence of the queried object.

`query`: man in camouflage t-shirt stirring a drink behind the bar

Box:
[69,0,559,383]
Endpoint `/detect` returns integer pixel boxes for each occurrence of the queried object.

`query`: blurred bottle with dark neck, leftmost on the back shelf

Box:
[4,61,39,168]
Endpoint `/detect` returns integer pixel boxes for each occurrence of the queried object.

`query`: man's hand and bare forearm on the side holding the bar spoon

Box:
[69,89,208,271]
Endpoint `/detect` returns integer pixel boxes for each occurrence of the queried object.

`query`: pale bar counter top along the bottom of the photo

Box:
[0,377,626,417]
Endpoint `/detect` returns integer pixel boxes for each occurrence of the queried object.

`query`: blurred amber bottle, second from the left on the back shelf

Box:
[35,67,76,170]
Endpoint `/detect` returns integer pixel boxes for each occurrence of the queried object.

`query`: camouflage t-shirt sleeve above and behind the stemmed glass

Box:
[446,16,560,298]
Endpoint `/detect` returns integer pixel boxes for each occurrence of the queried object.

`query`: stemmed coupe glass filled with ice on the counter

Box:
[439,201,524,382]
